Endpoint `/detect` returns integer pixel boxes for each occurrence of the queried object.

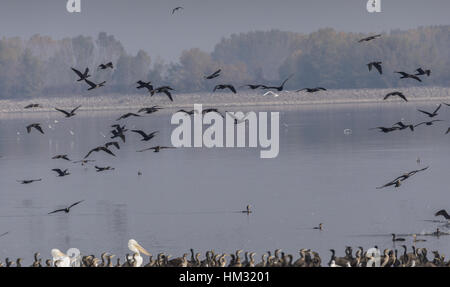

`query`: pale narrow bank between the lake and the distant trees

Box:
[0,87,450,114]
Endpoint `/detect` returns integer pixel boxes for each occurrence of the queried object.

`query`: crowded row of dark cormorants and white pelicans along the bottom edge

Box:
[0,242,450,267]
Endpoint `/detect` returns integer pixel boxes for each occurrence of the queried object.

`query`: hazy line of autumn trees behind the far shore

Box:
[0,26,450,99]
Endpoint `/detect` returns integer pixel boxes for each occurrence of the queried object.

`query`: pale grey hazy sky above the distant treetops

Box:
[0,0,450,61]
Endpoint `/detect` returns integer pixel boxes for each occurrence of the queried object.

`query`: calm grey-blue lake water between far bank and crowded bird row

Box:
[0,103,450,264]
